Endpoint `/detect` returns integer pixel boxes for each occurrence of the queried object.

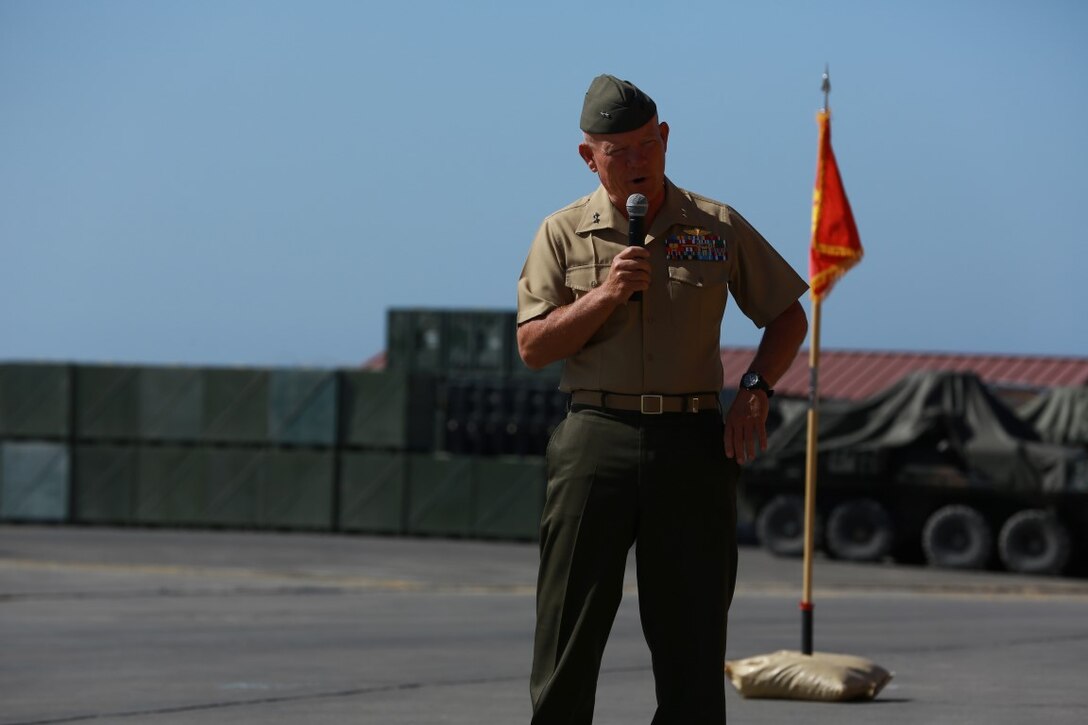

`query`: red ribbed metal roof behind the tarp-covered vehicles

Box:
[721,347,1088,401]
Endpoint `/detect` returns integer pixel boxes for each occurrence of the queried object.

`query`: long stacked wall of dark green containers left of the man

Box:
[0,309,558,539]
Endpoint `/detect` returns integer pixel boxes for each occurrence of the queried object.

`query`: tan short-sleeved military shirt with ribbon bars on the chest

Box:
[518,181,807,394]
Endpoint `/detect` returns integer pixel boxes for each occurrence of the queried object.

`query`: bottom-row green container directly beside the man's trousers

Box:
[472,458,547,540]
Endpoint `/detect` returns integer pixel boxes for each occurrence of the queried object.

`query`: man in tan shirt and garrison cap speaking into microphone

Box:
[518,75,807,725]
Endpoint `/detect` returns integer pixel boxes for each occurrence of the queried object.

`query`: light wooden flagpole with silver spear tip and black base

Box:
[801,65,831,655]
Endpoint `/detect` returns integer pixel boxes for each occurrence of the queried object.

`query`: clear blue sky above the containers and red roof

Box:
[0,0,1088,366]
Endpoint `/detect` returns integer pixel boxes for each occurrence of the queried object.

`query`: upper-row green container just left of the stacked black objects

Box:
[341,371,438,451]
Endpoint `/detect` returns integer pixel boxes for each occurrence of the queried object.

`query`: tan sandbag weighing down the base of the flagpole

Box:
[726,650,892,702]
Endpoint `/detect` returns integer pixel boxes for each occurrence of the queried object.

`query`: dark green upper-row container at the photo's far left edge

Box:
[0,363,72,439]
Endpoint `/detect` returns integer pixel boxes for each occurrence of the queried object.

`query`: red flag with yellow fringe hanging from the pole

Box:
[808,111,864,300]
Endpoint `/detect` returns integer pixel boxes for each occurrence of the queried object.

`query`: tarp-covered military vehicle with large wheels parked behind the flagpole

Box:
[741,372,1088,574]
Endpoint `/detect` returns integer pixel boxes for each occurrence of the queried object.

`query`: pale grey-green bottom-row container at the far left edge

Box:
[0,442,69,521]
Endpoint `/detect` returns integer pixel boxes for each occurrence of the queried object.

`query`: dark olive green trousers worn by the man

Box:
[530,407,739,725]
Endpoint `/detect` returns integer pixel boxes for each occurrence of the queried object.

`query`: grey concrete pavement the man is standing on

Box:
[0,526,1088,725]
